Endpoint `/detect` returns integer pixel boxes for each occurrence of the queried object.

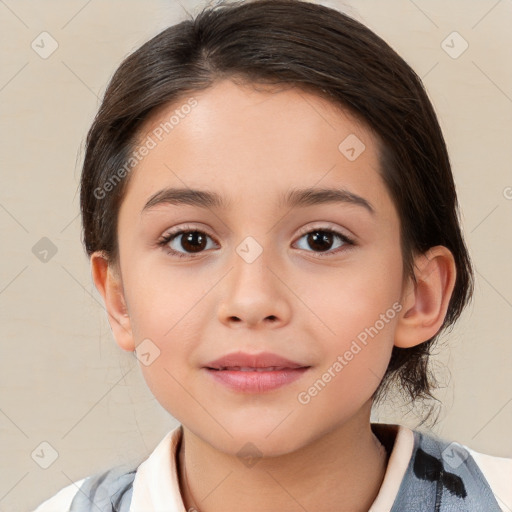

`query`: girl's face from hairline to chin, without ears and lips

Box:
[112,80,405,455]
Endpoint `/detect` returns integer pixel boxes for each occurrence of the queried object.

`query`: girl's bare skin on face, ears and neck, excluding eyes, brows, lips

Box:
[91,80,455,512]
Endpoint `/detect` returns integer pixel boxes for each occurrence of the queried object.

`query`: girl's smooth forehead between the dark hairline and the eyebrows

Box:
[124,80,389,216]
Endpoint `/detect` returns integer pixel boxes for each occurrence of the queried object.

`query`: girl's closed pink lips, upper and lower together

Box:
[203,352,311,393]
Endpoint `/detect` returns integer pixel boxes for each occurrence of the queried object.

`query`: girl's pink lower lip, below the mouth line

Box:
[205,367,309,393]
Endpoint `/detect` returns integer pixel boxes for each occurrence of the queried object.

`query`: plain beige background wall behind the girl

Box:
[0,0,512,511]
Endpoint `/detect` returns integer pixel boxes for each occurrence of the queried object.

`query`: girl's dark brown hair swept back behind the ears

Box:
[80,0,474,424]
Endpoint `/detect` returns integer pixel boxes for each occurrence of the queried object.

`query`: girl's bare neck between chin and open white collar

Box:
[177,404,387,512]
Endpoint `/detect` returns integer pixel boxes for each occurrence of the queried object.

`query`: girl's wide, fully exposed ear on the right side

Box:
[394,245,457,348]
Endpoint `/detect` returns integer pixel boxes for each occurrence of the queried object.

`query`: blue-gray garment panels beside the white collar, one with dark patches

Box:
[70,431,501,512]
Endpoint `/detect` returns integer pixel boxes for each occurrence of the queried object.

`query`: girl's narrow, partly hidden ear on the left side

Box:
[91,251,135,352]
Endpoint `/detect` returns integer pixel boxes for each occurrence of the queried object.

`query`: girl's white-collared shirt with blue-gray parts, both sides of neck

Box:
[34,424,512,512]
